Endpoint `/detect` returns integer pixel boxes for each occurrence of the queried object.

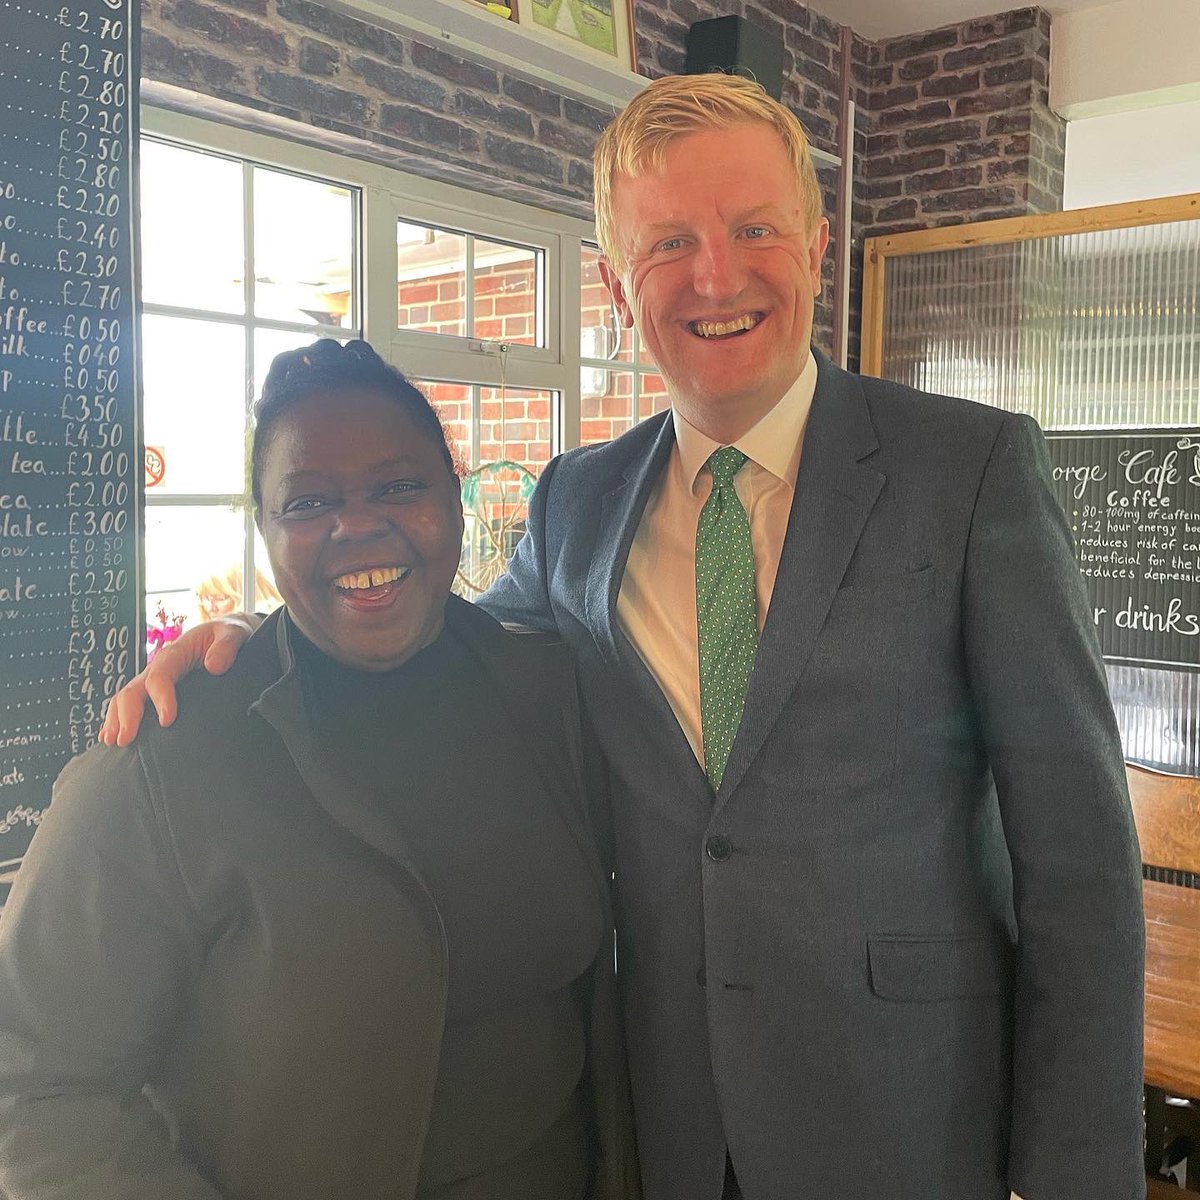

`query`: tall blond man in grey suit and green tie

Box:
[103,76,1144,1200]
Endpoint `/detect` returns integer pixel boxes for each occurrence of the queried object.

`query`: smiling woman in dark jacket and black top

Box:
[0,341,635,1200]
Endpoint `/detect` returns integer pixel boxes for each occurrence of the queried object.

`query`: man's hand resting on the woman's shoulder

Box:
[100,613,259,746]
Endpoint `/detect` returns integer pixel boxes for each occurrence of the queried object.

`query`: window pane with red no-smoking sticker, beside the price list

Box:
[142,314,246,497]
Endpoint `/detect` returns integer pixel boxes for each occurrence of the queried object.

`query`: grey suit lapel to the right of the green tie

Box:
[716,354,884,808]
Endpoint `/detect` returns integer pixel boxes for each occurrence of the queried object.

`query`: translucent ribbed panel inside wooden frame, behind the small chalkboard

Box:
[883,221,1200,775]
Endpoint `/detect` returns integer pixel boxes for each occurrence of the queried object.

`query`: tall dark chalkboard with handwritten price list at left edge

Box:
[0,0,142,898]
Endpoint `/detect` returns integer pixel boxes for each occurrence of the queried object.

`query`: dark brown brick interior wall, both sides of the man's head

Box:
[142,0,1063,366]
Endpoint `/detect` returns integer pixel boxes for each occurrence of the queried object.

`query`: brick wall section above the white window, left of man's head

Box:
[142,0,611,214]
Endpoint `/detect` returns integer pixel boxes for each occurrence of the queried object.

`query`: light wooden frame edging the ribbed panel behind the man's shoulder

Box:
[859,192,1200,376]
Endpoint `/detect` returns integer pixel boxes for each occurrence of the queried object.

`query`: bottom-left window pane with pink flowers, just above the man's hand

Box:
[145,505,245,649]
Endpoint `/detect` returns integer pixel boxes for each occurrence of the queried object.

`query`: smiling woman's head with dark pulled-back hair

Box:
[251,341,463,671]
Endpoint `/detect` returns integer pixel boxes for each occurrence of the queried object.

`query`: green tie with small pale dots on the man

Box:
[696,446,758,792]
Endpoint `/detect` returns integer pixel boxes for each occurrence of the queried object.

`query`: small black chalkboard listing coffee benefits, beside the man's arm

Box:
[1048,430,1200,671]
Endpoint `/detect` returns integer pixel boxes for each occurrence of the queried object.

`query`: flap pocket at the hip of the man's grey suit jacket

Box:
[866,935,1012,1002]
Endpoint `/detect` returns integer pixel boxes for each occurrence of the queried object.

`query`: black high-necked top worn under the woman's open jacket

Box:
[295,630,602,1200]
